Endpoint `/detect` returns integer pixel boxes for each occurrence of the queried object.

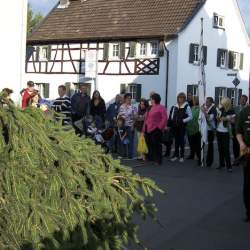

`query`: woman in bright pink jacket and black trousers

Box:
[143,93,167,165]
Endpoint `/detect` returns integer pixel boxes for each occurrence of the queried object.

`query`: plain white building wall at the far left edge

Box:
[0,0,27,101]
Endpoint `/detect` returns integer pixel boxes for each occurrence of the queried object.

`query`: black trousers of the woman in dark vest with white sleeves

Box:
[173,126,186,158]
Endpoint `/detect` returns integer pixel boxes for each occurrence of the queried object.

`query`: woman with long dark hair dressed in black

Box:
[90,90,106,128]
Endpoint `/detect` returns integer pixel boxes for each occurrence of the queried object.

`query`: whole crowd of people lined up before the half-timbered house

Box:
[1,81,250,221]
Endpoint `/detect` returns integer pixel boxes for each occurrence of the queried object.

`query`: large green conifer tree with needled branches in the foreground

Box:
[0,96,161,250]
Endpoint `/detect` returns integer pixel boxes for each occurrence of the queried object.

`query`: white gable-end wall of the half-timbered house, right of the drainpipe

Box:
[174,0,250,106]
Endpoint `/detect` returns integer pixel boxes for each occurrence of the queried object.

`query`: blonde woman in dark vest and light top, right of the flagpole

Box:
[217,97,235,172]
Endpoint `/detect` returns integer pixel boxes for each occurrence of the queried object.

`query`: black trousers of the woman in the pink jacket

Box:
[145,129,162,164]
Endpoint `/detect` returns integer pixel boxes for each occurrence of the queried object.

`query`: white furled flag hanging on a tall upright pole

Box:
[198,18,207,166]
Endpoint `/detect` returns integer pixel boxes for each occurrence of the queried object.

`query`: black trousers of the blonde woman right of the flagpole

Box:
[217,132,232,168]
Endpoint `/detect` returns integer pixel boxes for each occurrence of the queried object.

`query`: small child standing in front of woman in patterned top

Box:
[117,116,129,157]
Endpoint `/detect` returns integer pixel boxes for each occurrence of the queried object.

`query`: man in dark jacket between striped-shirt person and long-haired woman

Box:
[71,84,90,122]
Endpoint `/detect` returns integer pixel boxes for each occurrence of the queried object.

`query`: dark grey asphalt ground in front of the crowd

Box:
[124,160,250,250]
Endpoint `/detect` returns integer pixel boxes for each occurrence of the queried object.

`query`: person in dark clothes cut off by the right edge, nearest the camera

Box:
[236,106,250,222]
